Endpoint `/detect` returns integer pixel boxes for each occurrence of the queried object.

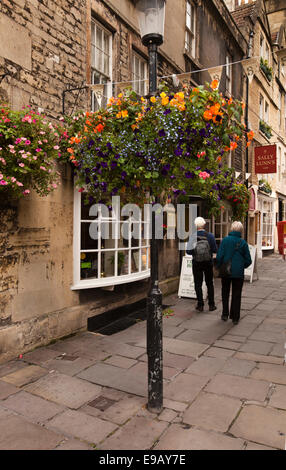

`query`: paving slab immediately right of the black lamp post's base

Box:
[164,373,209,403]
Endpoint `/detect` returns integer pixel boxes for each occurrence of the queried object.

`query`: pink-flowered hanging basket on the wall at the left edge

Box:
[0,104,60,200]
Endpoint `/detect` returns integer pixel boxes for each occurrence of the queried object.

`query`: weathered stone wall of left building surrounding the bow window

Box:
[0,0,182,362]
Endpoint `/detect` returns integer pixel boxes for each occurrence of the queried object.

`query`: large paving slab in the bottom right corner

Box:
[230,405,286,449]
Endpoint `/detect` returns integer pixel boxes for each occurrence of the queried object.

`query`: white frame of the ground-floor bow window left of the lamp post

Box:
[71,188,151,290]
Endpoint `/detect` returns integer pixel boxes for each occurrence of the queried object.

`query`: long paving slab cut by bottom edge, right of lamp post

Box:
[154,424,244,451]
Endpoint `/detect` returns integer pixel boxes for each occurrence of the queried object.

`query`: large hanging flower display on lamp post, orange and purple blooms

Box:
[62,81,252,220]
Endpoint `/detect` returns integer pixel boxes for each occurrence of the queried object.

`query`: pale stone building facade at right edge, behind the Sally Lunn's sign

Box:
[226,0,286,257]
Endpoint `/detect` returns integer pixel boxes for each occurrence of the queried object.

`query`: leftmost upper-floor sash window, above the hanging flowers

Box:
[91,20,112,111]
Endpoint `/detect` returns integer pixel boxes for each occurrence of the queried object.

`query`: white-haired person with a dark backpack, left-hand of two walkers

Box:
[186,217,217,312]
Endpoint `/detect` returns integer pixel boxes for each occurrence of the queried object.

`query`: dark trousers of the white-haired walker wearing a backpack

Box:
[193,262,214,307]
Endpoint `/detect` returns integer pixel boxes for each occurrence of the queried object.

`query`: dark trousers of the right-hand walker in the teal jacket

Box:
[221,278,243,320]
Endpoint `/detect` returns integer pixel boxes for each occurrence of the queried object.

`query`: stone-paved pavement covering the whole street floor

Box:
[0,255,286,450]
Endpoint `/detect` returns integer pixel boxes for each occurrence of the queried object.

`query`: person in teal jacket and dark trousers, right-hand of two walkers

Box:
[216,222,252,325]
